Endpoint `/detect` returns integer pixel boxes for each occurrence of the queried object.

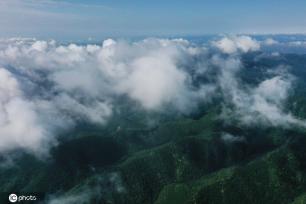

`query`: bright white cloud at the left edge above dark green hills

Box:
[0,68,51,153]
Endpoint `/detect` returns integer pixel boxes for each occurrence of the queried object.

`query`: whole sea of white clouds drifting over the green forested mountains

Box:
[0,36,305,155]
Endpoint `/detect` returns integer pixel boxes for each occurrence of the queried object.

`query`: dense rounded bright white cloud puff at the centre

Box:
[118,55,186,109]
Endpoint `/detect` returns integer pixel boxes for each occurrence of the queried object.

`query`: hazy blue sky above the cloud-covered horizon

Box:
[0,0,306,39]
